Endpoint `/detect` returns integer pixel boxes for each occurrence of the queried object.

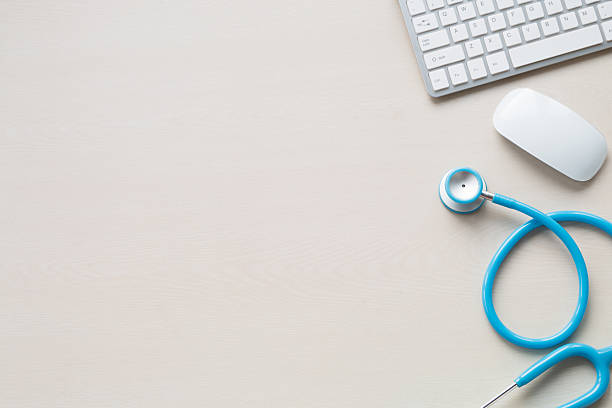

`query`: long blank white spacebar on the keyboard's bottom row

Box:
[508,24,603,68]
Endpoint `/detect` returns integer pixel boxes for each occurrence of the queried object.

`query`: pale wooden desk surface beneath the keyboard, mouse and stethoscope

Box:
[0,0,612,408]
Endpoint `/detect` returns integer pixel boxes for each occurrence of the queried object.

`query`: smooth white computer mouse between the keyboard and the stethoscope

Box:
[493,88,608,181]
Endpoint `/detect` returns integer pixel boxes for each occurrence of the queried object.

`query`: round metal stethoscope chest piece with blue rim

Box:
[440,167,492,214]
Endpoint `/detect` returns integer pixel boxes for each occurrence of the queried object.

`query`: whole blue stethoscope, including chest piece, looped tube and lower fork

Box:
[440,167,612,408]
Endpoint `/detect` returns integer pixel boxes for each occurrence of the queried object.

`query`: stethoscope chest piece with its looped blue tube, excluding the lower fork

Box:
[440,167,612,349]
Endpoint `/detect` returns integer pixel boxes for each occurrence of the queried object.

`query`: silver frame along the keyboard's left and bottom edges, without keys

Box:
[398,0,612,98]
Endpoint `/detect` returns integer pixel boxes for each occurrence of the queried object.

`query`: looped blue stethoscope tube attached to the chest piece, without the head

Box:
[482,194,612,349]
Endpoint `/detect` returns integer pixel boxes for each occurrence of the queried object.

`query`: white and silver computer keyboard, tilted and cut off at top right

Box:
[400,0,612,97]
